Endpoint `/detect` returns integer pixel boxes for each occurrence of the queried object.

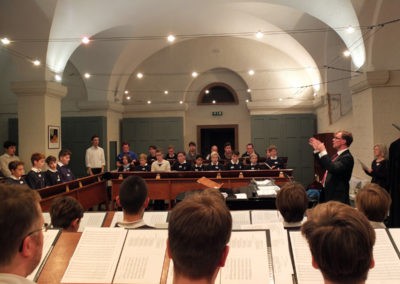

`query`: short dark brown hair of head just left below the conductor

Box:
[275,182,308,222]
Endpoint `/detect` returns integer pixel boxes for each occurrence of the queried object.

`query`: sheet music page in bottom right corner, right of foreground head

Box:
[367,229,400,284]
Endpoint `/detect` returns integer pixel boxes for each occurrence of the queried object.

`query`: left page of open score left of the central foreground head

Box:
[61,227,127,283]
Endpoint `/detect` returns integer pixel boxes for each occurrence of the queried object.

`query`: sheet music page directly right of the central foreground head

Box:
[216,231,273,283]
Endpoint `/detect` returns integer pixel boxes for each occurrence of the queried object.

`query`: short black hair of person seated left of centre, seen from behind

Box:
[119,176,148,214]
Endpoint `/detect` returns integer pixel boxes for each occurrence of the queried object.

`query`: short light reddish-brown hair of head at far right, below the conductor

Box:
[356,183,392,222]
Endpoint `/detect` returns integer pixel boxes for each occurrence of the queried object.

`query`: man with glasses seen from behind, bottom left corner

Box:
[0,184,47,284]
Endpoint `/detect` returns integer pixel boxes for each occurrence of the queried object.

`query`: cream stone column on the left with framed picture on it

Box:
[11,81,67,170]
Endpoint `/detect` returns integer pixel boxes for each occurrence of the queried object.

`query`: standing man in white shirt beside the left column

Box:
[85,135,106,175]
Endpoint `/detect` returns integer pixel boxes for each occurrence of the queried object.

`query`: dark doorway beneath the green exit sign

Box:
[197,124,238,157]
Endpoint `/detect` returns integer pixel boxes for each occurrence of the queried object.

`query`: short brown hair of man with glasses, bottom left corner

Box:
[0,184,41,267]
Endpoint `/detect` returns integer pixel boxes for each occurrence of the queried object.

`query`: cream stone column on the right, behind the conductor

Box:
[350,70,400,179]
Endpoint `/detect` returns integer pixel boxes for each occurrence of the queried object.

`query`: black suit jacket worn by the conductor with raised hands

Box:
[316,150,354,204]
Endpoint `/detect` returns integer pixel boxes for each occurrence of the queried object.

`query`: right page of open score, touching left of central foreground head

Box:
[113,230,168,284]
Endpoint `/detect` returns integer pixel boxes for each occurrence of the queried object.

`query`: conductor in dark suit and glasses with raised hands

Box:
[309,131,354,204]
